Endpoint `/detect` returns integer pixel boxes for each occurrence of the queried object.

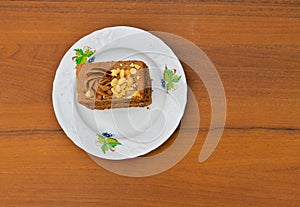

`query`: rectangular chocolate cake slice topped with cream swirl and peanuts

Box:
[76,60,152,110]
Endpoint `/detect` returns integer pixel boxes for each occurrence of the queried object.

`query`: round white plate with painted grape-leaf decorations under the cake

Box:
[52,26,187,160]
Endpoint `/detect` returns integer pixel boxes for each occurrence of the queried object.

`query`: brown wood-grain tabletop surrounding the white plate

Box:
[0,0,300,207]
